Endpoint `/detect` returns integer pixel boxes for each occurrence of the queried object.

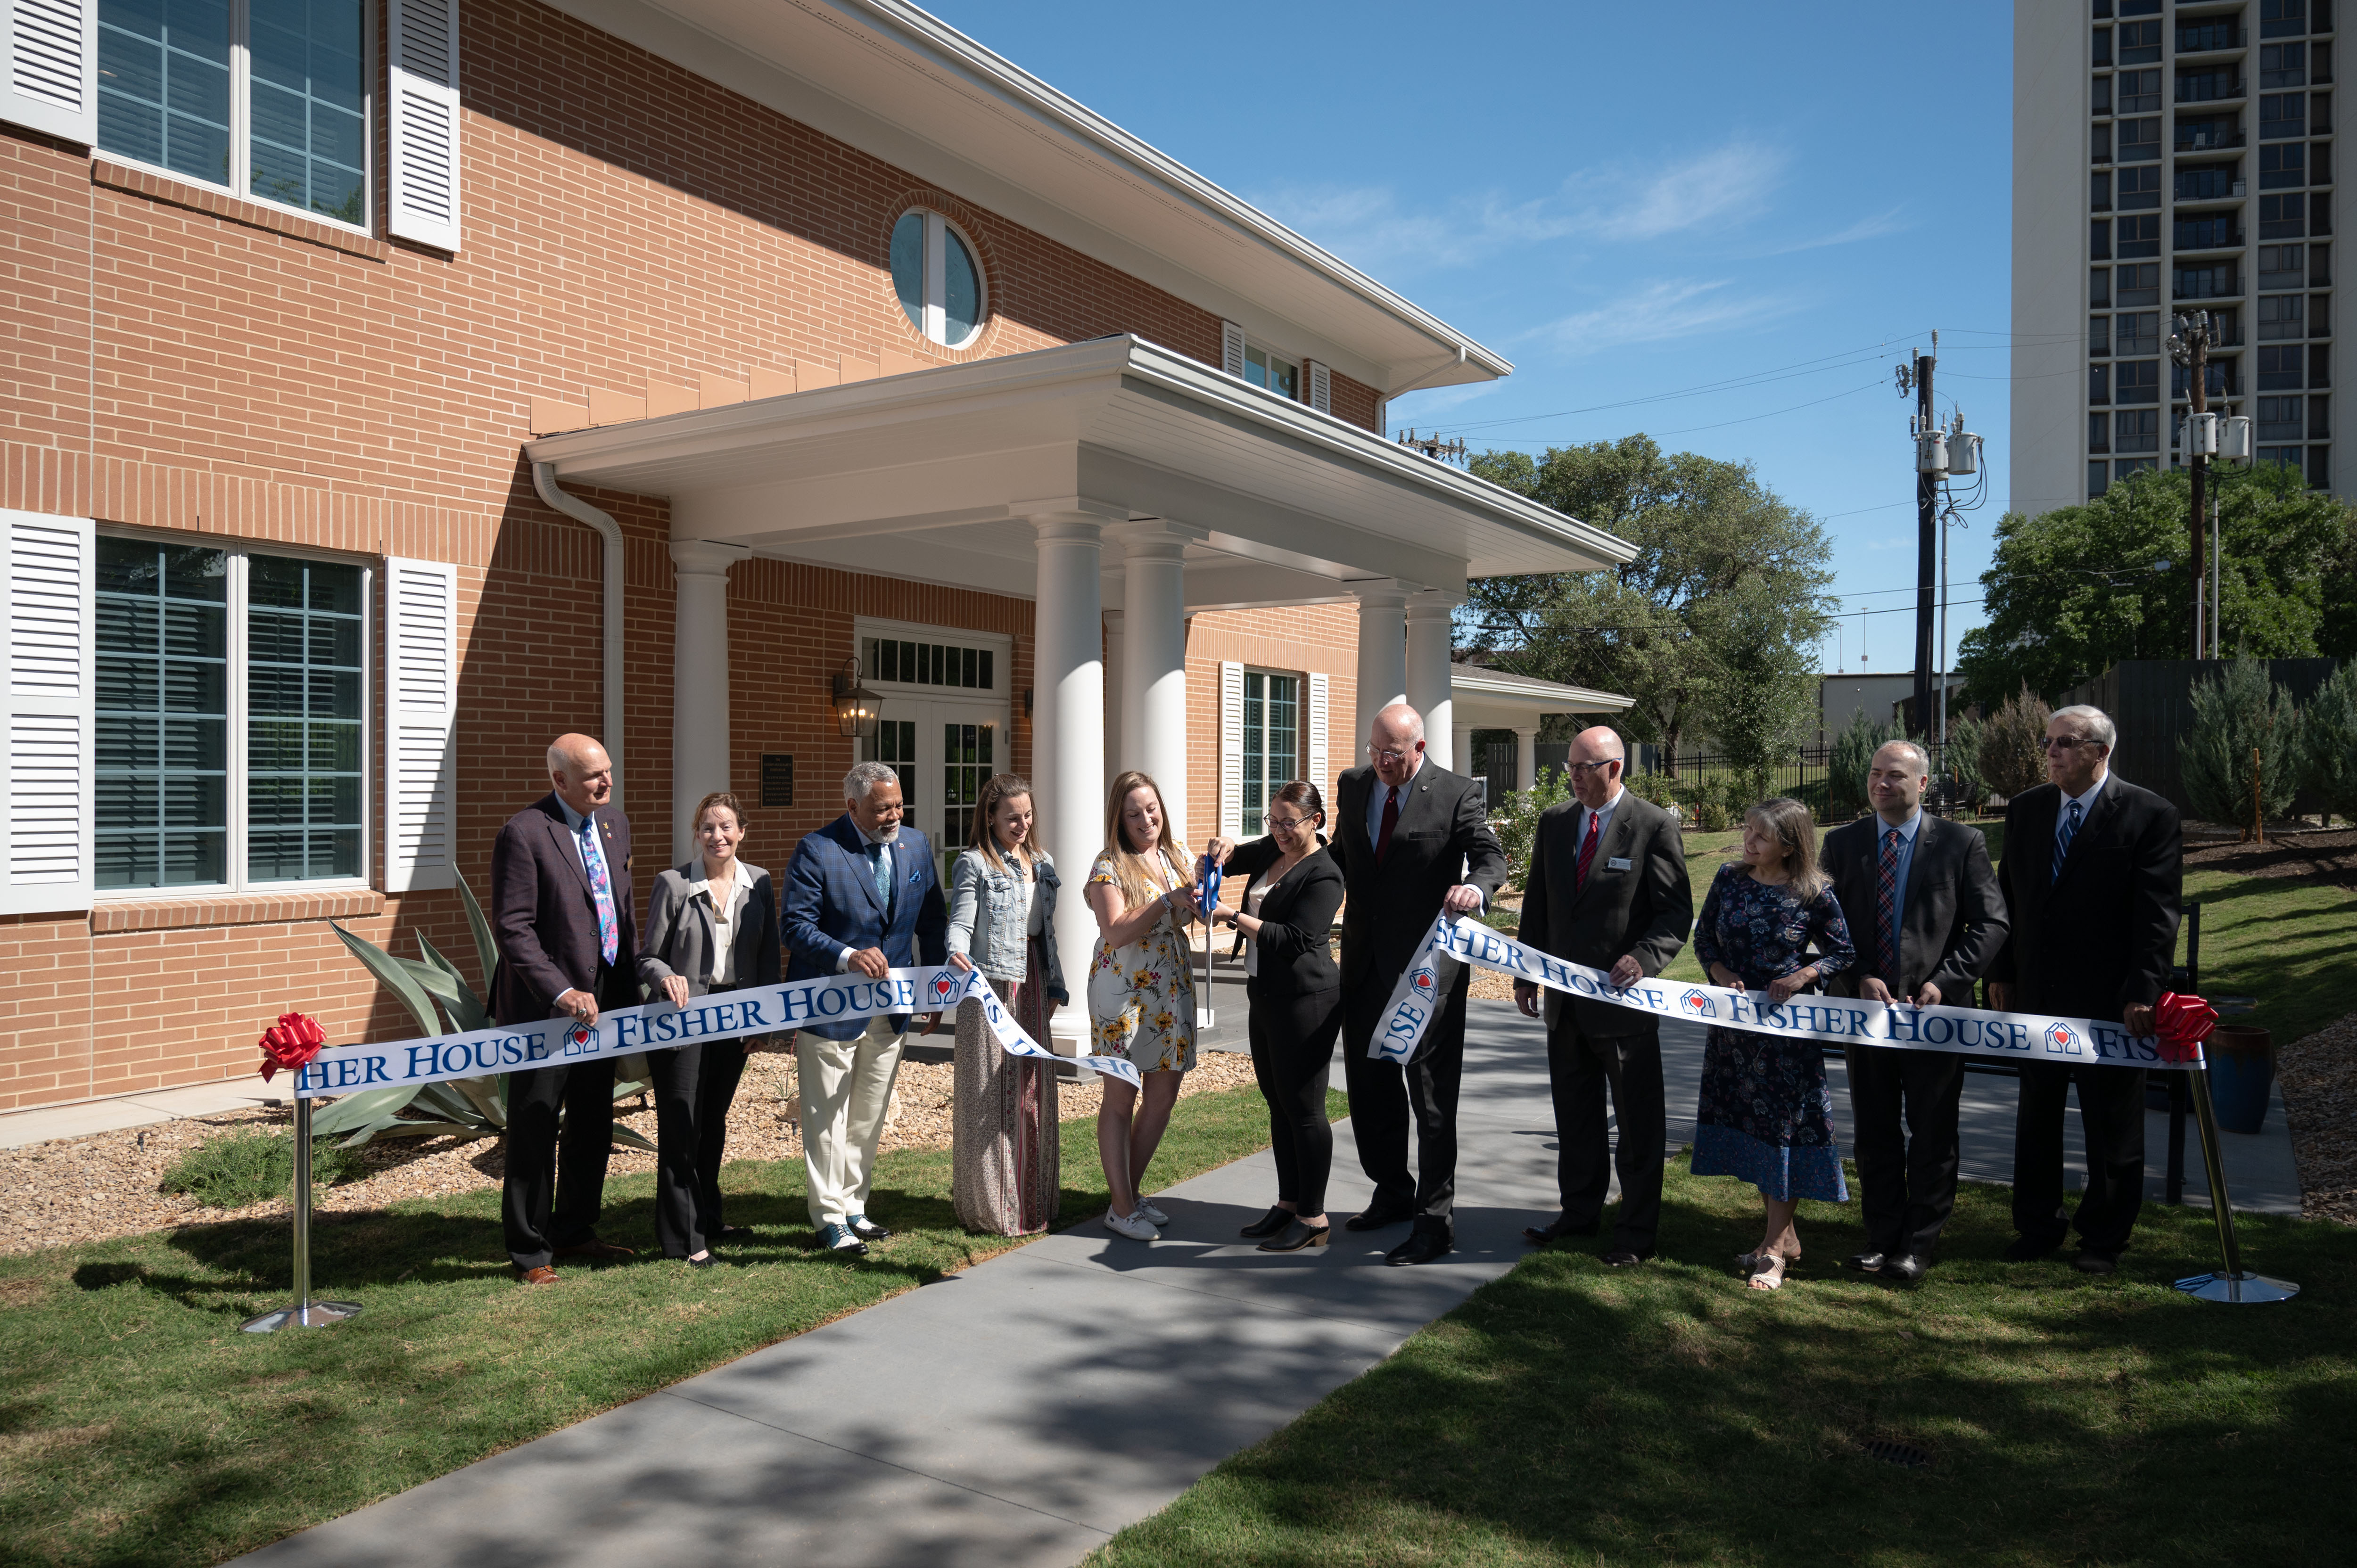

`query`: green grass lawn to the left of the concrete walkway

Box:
[0,1087,1343,1566]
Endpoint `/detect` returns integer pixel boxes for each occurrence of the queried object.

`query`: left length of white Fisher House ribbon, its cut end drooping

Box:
[295,967,1141,1099]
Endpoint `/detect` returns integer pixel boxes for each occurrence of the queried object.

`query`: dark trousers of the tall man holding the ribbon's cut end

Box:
[1341,969,1473,1229]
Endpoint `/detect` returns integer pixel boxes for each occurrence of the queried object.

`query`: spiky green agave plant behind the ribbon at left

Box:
[311,877,655,1153]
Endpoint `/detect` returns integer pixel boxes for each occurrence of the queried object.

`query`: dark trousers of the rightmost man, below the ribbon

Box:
[2013,1061,2145,1252]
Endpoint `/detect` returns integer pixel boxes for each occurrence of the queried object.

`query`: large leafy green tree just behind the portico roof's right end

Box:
[1466,436,1831,773]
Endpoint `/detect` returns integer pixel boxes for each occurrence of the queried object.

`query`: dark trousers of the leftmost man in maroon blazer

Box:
[500,1056,613,1269]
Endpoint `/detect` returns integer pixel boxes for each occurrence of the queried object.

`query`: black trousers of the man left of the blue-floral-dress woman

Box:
[1546,1023,1669,1257]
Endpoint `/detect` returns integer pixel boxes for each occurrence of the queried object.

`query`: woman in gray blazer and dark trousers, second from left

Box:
[639,795,780,1269]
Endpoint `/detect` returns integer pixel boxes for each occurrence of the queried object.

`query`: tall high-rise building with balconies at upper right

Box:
[2011,0,2329,512]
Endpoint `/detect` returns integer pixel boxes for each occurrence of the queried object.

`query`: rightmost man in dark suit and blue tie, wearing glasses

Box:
[1989,707,2185,1273]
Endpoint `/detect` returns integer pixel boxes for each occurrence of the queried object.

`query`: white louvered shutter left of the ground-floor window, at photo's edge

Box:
[0,512,97,915]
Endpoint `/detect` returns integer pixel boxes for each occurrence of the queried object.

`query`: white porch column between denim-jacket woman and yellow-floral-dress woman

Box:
[1030,509,1105,1054]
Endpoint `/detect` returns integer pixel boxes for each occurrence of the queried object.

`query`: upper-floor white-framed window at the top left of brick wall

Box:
[97,0,370,229]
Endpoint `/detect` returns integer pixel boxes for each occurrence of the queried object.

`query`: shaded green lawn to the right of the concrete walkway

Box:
[1089,1167,2357,1568]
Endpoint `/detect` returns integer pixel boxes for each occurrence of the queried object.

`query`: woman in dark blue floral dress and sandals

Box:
[1695,799,1857,1290]
